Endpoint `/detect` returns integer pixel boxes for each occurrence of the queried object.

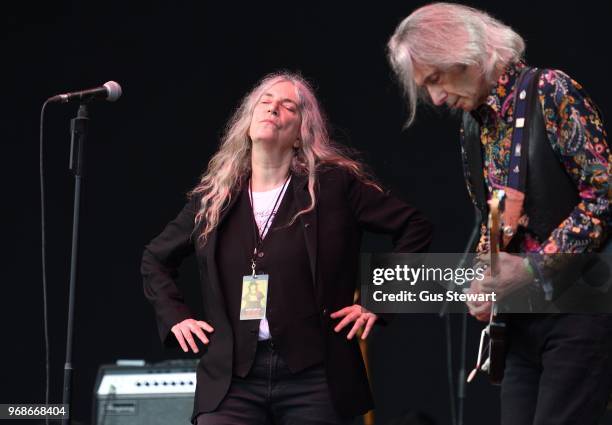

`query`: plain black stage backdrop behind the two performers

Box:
[0,0,612,424]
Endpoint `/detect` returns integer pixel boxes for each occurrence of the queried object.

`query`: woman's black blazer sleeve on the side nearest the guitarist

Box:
[346,168,433,252]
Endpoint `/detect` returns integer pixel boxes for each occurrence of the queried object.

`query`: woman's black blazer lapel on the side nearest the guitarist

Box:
[292,174,318,287]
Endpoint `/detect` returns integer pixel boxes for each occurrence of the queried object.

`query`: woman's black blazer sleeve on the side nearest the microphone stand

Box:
[140,196,197,346]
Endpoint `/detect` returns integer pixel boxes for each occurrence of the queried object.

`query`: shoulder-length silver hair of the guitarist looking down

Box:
[387,3,525,126]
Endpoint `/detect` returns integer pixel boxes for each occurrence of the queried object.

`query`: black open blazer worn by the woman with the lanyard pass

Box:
[141,168,431,420]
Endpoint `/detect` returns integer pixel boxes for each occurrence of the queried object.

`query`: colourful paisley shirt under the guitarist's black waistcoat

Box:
[461,62,612,290]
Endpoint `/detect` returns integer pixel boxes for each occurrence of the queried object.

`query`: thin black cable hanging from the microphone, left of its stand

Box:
[39,100,51,425]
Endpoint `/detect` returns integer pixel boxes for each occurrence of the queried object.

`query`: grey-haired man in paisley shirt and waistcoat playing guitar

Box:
[388,3,612,425]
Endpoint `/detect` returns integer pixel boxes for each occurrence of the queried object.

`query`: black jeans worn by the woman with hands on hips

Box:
[197,341,352,425]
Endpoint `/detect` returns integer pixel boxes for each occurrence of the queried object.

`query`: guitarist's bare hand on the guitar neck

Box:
[466,252,534,321]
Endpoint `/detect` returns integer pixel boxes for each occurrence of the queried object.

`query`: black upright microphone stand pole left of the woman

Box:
[62,103,89,425]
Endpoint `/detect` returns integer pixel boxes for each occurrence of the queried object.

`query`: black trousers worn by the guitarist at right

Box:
[501,314,612,425]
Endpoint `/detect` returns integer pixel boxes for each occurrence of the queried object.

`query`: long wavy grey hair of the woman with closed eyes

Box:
[190,72,380,243]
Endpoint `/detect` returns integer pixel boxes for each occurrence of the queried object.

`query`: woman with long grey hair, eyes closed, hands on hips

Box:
[142,73,431,425]
